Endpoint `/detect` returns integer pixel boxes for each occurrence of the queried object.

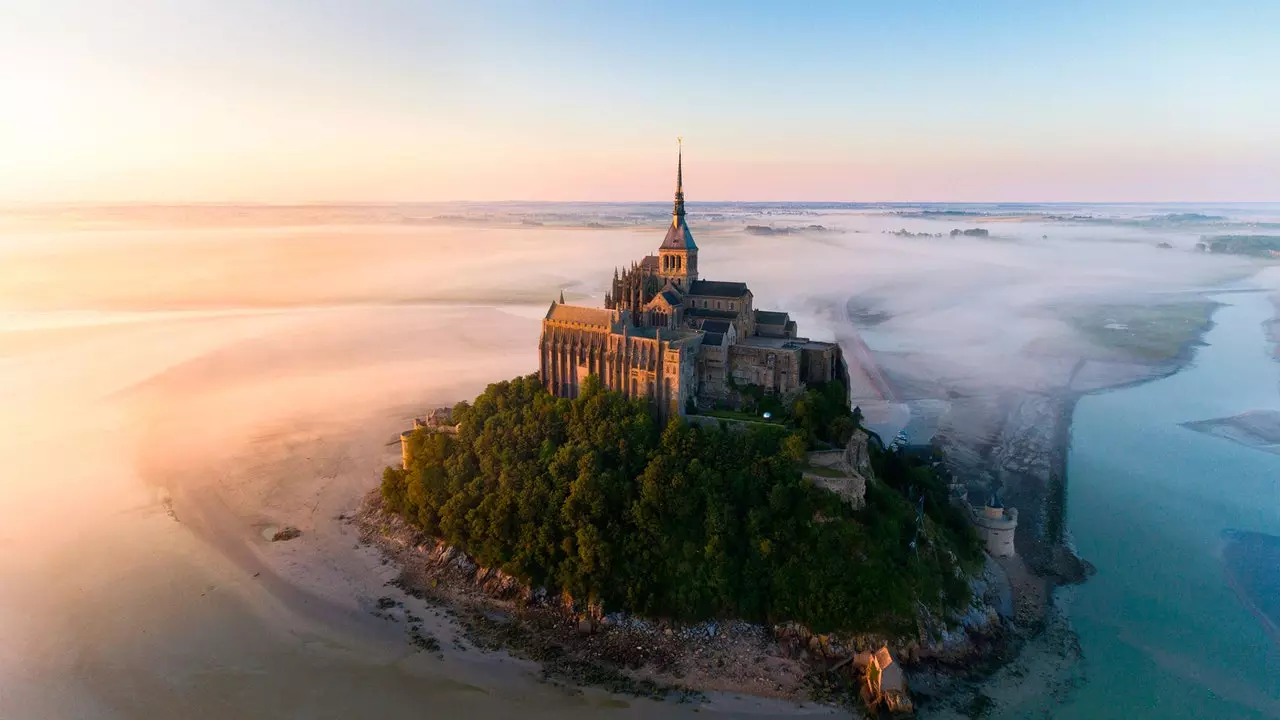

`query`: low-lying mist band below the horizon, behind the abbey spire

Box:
[0,199,1275,392]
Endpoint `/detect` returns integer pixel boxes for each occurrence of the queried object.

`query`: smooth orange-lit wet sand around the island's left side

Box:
[0,301,834,719]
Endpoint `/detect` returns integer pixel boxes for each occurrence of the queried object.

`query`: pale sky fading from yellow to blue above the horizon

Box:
[0,0,1280,202]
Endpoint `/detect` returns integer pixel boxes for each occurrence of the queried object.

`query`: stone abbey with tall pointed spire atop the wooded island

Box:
[538,147,849,418]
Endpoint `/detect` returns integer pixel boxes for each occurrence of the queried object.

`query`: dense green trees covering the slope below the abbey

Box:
[381,375,982,632]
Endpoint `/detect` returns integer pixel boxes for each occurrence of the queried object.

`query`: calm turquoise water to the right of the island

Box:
[1053,288,1280,719]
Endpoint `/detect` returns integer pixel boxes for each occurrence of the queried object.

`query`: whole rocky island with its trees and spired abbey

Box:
[358,151,1016,711]
